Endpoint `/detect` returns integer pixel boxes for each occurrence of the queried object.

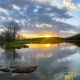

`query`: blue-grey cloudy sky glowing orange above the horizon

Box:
[0,0,80,37]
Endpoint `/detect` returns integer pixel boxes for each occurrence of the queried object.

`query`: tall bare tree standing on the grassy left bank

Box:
[2,21,21,42]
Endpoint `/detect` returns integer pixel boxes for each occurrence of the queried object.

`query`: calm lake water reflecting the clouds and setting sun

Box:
[0,43,80,80]
